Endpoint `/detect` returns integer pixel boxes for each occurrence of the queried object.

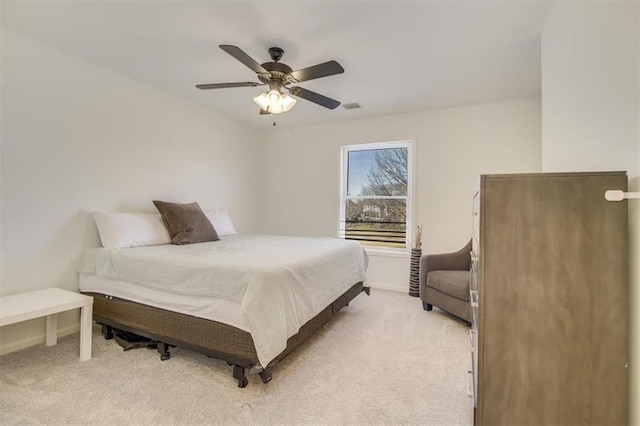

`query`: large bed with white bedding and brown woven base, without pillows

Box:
[79,233,369,387]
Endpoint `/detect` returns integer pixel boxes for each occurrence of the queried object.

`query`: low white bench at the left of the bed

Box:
[0,288,93,361]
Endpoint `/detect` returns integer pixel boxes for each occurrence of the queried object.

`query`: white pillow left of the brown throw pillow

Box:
[93,212,171,248]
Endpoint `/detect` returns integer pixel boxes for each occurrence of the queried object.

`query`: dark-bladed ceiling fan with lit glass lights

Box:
[196,44,344,114]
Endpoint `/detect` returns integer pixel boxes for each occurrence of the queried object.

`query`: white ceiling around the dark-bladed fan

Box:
[2,0,551,127]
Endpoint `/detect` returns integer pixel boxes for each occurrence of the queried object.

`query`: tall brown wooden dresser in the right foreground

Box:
[470,172,629,426]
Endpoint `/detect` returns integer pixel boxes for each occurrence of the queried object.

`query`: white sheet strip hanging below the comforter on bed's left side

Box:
[79,274,251,332]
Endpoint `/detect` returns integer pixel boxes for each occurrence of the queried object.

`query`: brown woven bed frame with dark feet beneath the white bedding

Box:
[84,282,370,388]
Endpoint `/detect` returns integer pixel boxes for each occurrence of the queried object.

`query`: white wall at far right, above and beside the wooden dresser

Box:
[542,2,640,425]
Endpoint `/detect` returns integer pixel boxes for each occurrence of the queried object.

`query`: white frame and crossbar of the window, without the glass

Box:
[338,139,415,255]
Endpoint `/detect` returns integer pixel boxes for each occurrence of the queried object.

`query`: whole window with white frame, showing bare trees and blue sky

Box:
[339,141,412,249]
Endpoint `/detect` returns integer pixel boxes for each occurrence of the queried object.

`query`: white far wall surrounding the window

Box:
[263,99,541,291]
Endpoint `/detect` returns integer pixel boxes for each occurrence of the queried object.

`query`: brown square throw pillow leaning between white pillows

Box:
[153,200,220,245]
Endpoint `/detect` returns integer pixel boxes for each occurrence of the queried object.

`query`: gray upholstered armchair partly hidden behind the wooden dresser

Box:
[420,240,471,323]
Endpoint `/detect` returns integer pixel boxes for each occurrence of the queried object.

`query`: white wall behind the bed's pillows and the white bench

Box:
[0,29,263,353]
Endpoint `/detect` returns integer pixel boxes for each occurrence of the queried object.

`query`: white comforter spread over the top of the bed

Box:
[79,235,368,366]
